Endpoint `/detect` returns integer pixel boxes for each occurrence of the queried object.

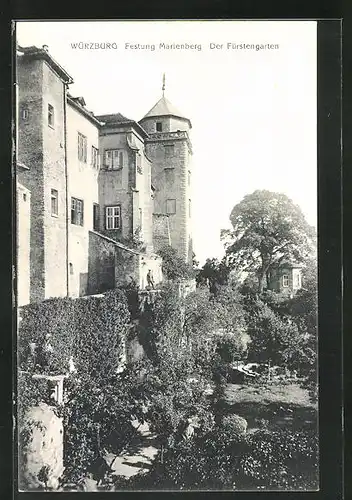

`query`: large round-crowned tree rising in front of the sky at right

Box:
[222,190,315,292]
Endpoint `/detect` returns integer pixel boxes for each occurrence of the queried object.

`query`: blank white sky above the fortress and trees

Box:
[16,21,317,264]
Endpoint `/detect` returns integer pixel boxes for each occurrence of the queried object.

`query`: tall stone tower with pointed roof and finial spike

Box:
[139,85,193,262]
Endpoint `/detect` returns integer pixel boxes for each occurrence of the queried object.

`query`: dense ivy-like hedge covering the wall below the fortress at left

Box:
[18,290,129,380]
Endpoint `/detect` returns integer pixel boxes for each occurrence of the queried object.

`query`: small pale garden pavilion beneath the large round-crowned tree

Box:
[268,262,302,294]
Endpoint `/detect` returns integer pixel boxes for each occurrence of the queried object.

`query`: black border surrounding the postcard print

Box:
[0,6,342,500]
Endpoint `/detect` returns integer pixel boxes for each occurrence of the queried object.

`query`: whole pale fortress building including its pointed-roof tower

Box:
[16,46,192,305]
